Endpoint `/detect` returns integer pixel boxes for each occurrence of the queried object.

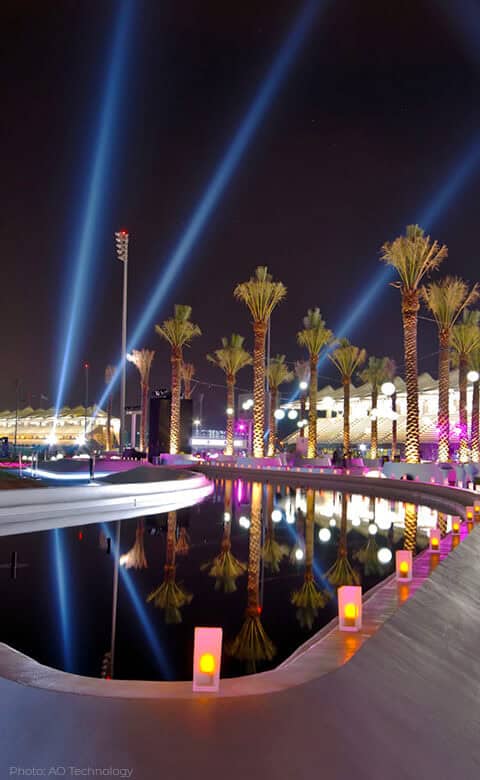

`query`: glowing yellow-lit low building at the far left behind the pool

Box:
[0,406,120,447]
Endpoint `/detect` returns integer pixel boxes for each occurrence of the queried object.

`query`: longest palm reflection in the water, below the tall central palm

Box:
[228,482,276,672]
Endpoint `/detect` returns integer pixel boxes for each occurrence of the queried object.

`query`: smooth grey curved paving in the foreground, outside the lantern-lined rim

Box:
[0,528,480,780]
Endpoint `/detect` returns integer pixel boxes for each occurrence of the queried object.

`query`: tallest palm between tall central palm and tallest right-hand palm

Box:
[297,308,333,458]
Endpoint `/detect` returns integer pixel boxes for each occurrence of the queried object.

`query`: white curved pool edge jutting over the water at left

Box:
[0,473,213,536]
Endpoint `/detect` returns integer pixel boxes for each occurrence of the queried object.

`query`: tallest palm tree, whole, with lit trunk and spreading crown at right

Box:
[381,225,447,463]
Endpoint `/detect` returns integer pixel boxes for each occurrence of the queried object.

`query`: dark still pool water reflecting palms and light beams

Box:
[0,481,450,680]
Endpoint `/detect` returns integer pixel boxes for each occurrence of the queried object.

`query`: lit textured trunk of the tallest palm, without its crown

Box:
[402,291,420,463]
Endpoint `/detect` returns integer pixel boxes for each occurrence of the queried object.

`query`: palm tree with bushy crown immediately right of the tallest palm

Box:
[421,276,478,463]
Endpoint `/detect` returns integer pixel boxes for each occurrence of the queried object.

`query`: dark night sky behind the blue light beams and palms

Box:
[0,0,480,424]
